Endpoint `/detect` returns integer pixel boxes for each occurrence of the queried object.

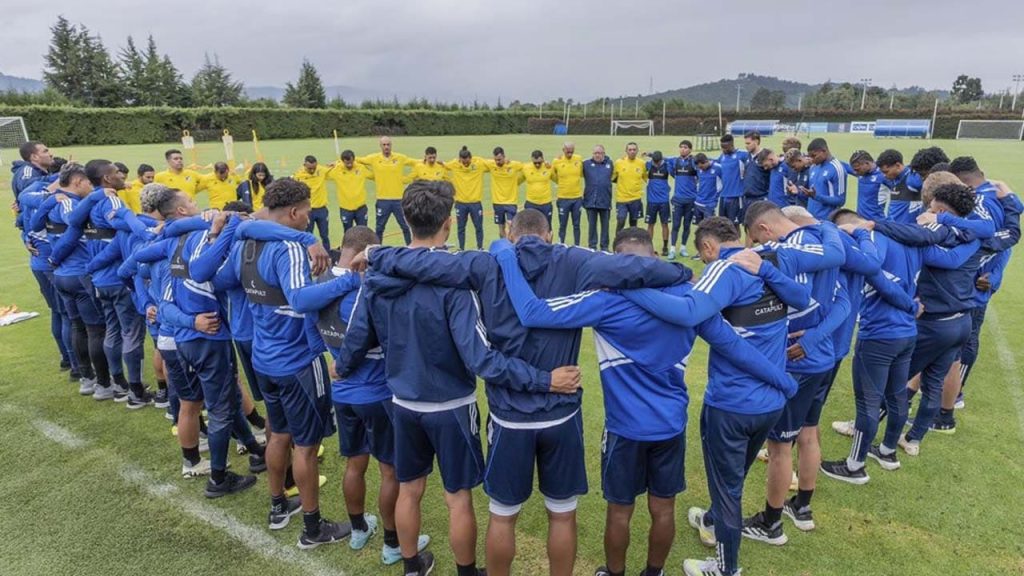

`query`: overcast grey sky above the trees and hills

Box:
[0,0,1024,104]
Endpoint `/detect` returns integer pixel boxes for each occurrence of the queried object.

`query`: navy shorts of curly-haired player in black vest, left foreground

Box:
[256,356,334,446]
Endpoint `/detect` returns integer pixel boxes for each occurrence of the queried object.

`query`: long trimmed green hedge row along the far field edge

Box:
[0,106,1017,146]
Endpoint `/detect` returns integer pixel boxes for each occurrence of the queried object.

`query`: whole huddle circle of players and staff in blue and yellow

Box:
[13,133,1022,576]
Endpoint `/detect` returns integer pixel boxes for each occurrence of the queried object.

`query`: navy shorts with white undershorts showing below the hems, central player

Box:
[483,411,588,506]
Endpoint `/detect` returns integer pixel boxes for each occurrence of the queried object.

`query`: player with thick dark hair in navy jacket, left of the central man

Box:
[338,181,580,576]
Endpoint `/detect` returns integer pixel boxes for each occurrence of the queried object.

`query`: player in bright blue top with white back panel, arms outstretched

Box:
[498,228,800,576]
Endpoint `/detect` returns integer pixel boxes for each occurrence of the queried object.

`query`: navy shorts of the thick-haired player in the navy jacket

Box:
[392,402,483,487]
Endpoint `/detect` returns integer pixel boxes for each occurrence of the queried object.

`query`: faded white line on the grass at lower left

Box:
[0,405,345,576]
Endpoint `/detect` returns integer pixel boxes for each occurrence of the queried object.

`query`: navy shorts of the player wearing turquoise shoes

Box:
[334,399,394,466]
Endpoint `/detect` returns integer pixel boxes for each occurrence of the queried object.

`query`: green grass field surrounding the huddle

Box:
[0,135,1024,576]
